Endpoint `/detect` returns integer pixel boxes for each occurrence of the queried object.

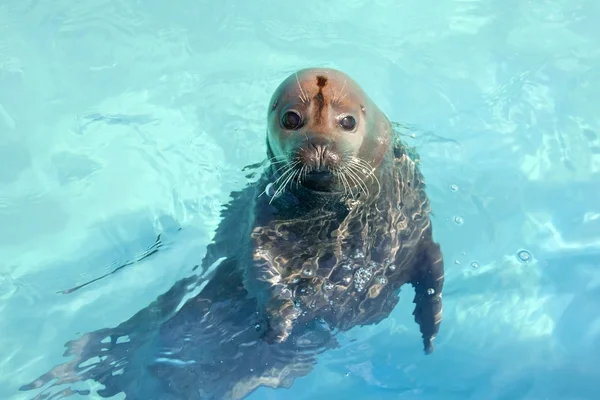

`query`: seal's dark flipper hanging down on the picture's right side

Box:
[411,226,444,354]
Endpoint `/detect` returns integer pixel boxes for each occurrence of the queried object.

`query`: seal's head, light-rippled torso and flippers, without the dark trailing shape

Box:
[245,69,444,353]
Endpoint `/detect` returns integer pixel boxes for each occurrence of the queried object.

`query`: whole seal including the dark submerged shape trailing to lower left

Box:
[22,68,444,400]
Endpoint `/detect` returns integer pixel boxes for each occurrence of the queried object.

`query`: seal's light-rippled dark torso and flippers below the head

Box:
[251,141,444,346]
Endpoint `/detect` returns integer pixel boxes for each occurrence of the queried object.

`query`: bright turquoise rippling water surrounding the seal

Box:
[0,0,600,400]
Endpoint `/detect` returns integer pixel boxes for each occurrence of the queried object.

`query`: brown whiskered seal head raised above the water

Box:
[267,68,391,192]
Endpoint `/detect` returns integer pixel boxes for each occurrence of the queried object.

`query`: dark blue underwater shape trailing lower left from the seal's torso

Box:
[20,180,337,400]
